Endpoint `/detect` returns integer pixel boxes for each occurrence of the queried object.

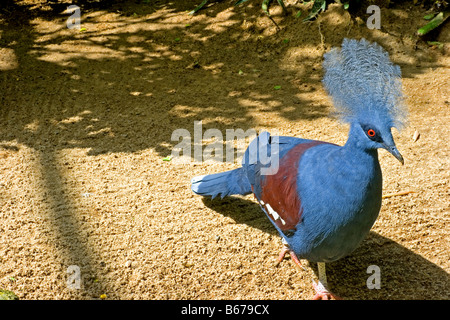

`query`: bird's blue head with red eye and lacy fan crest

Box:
[323,39,406,164]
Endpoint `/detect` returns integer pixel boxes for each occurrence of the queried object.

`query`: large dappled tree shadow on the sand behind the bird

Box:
[0,0,444,156]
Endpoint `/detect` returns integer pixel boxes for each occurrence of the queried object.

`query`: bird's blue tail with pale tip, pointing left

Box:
[191,168,252,199]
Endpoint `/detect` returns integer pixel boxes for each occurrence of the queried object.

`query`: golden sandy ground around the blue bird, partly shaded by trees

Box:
[0,0,450,299]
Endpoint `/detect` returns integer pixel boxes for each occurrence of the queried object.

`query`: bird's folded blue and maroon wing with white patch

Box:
[243,132,330,234]
